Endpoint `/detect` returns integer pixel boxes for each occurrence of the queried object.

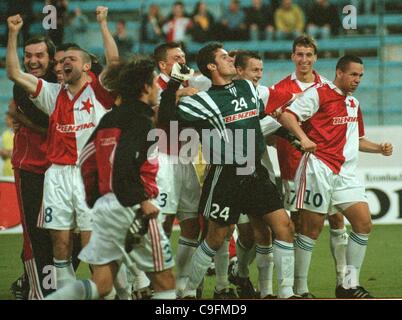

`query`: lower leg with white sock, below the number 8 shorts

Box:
[50,230,76,289]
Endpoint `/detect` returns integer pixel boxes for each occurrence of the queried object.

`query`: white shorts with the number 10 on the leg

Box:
[295,153,367,215]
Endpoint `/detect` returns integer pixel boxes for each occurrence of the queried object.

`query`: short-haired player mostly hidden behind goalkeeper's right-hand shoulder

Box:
[229,50,290,299]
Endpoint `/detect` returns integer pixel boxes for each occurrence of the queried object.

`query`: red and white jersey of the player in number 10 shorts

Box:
[286,82,364,175]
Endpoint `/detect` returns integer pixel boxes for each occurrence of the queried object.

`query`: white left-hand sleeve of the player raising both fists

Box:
[30,79,62,115]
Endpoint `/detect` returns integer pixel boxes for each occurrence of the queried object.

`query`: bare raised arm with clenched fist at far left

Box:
[6,14,38,95]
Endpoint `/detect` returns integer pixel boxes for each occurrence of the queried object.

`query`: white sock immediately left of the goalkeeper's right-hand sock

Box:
[255,244,274,298]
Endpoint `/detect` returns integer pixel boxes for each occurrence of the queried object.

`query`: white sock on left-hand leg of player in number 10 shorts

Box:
[295,234,315,294]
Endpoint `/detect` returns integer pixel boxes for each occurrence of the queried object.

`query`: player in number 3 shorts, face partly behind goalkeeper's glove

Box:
[154,42,203,296]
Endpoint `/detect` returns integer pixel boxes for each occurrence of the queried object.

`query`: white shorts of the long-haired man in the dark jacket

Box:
[79,193,174,272]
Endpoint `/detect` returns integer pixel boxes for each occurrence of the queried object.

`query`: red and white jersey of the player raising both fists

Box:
[31,72,114,165]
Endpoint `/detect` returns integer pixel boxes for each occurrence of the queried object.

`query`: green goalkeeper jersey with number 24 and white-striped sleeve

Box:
[177,80,265,165]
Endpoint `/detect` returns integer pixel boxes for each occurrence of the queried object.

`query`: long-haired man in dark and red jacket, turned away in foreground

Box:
[44,59,176,300]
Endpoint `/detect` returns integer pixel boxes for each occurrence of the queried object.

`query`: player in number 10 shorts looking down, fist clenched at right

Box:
[279,55,392,298]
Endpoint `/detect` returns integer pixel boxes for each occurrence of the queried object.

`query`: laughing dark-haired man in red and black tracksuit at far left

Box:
[9,32,56,300]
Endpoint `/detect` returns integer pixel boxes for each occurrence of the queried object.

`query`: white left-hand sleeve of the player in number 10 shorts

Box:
[286,88,320,122]
